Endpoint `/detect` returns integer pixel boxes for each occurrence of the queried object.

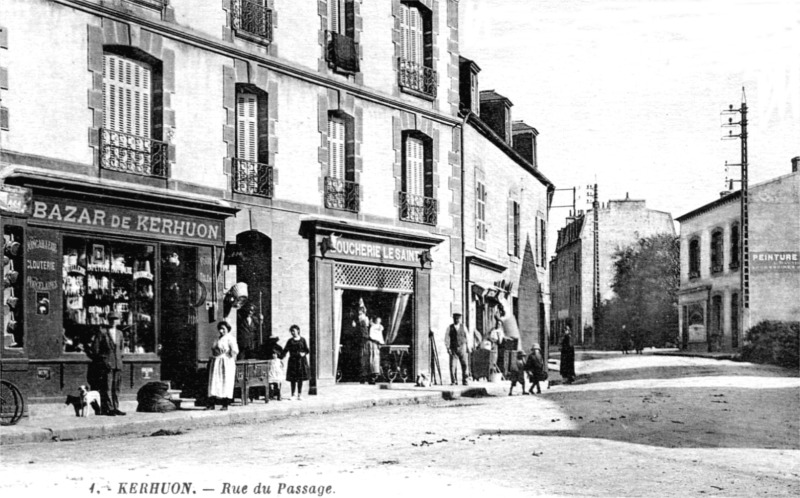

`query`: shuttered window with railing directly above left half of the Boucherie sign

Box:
[325,113,360,212]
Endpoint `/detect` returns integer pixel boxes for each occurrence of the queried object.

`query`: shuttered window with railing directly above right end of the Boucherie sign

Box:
[400,132,438,225]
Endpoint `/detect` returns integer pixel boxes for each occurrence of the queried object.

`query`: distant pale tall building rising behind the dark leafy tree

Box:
[550,196,675,344]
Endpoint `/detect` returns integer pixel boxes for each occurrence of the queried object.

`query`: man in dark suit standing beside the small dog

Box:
[87,313,125,417]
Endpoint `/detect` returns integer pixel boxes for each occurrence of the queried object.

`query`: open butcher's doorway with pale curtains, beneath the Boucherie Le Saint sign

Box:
[336,289,414,382]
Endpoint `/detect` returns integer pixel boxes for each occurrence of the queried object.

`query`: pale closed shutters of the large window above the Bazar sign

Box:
[103,54,152,138]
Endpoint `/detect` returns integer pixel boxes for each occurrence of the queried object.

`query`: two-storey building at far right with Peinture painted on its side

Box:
[677,157,800,351]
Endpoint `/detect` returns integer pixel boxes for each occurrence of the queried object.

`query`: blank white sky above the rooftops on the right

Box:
[460,0,800,233]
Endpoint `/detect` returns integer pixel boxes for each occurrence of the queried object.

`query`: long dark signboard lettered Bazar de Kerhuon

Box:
[31,198,223,244]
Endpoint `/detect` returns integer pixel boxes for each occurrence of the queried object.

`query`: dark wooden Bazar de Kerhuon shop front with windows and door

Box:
[1,179,234,401]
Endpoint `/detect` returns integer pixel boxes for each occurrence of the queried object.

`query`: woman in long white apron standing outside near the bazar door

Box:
[206,321,238,410]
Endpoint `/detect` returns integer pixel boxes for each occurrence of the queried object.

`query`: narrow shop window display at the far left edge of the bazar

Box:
[3,225,25,349]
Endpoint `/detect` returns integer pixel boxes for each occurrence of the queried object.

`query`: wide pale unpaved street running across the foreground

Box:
[0,357,800,497]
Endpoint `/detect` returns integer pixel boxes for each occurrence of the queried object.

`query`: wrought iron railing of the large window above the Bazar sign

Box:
[100,128,169,178]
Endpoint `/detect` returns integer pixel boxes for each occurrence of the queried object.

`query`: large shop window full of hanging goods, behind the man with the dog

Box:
[62,237,156,354]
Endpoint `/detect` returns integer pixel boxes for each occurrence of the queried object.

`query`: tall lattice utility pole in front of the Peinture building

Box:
[722,87,750,341]
